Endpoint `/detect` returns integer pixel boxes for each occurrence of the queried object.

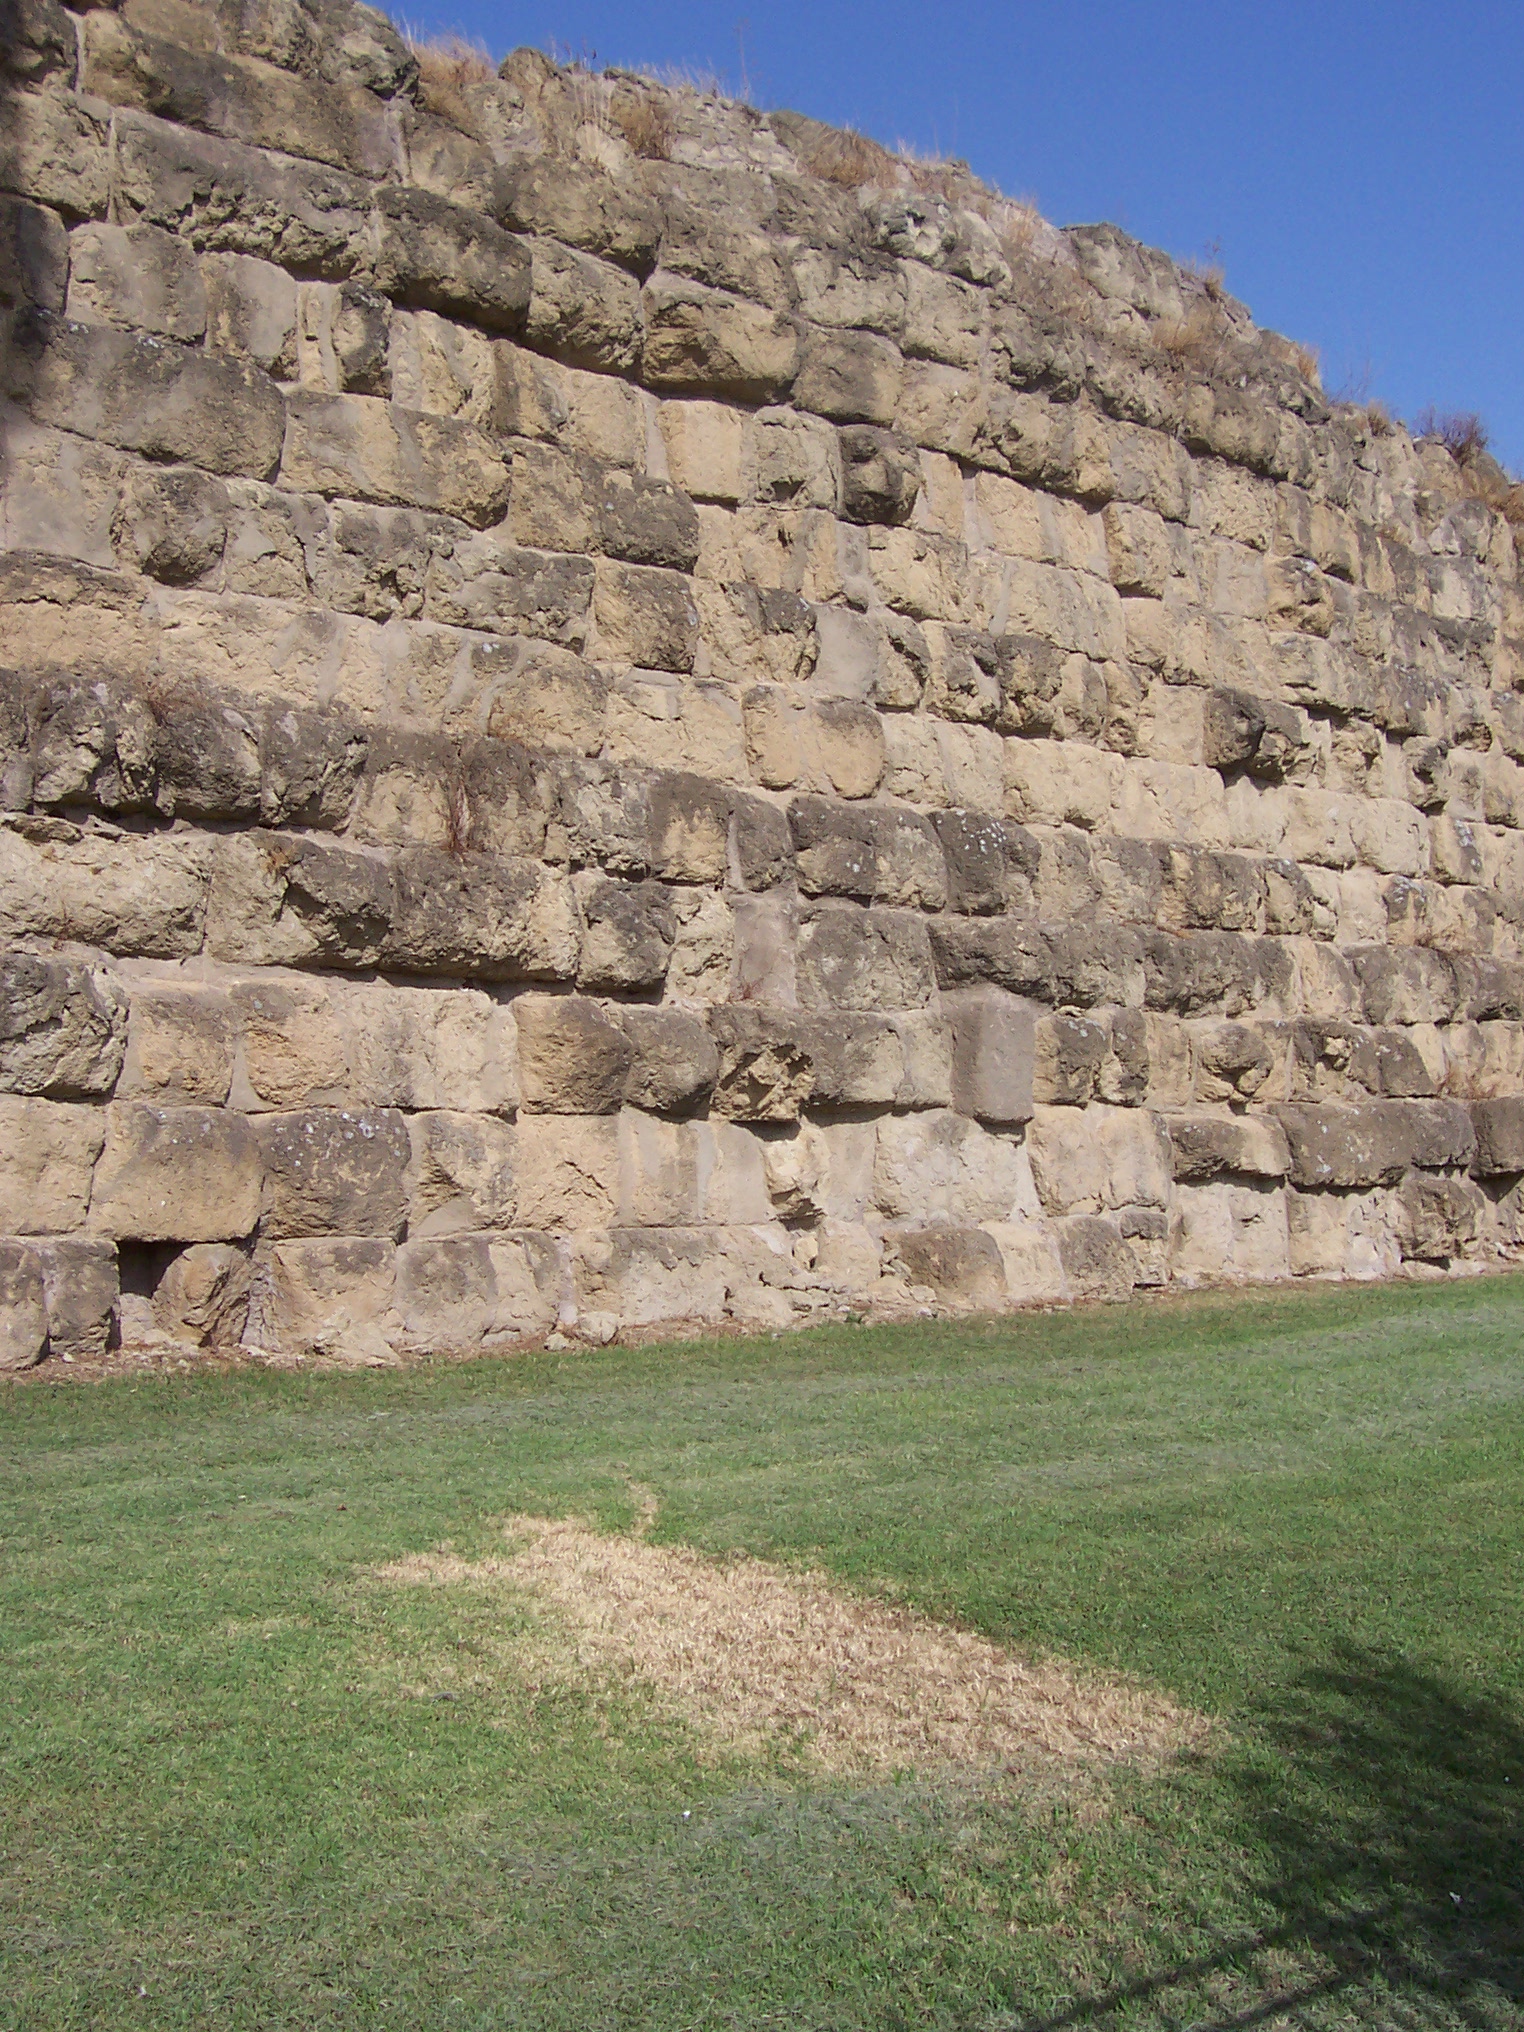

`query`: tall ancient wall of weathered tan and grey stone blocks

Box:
[0,0,1524,1366]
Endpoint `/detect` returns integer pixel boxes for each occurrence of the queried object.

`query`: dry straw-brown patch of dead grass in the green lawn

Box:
[380,1506,1211,1772]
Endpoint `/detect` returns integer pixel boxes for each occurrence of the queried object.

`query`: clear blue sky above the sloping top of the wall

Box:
[404,0,1524,469]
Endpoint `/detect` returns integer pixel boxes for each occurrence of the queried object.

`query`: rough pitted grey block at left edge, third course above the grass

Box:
[0,953,128,1101]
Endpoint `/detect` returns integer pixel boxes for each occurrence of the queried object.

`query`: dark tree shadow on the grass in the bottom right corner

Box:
[1016,1646,1524,2032]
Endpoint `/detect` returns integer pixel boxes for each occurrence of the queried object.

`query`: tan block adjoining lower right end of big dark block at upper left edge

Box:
[278,392,508,526]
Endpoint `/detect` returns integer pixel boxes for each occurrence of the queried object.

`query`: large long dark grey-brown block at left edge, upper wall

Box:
[6,311,284,480]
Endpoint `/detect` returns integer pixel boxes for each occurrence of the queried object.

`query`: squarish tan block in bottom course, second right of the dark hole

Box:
[244,1235,396,1363]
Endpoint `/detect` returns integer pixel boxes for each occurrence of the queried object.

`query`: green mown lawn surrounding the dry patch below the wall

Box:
[0,1278,1524,2032]
